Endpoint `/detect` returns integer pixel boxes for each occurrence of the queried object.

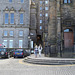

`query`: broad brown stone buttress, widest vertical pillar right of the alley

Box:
[48,0,57,57]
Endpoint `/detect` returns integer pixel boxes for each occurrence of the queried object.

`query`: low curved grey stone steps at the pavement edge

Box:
[24,59,75,65]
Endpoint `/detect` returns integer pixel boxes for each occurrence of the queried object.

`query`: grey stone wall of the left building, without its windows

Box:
[0,0,30,48]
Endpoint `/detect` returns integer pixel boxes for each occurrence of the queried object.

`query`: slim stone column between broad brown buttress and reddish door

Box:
[57,0,61,57]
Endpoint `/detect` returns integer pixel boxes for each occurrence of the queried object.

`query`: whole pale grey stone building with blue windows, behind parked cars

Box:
[0,0,30,48]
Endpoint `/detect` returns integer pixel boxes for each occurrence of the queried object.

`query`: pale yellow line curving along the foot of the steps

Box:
[19,59,75,67]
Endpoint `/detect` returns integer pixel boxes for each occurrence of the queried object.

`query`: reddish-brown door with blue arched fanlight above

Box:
[64,29,74,48]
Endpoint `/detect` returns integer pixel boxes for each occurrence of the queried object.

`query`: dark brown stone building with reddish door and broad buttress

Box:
[48,0,75,57]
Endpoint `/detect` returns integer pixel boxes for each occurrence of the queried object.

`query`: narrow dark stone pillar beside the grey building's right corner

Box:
[30,1,36,43]
